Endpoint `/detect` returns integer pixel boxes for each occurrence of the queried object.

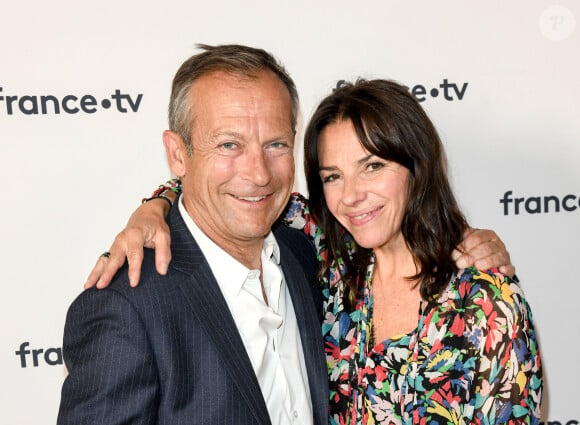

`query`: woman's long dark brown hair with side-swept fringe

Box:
[304,80,468,308]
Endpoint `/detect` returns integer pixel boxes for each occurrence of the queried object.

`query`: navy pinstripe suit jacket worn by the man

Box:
[58,205,328,425]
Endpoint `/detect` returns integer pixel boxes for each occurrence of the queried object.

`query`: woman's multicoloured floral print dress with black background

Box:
[286,194,542,425]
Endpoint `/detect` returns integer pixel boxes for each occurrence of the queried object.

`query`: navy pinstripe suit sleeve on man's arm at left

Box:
[57,289,159,425]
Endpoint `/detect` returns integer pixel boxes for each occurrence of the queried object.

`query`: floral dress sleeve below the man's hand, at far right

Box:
[466,272,542,424]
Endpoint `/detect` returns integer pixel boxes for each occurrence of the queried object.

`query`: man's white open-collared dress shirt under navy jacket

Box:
[179,197,313,425]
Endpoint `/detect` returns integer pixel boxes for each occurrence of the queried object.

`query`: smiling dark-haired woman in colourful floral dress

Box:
[89,80,542,424]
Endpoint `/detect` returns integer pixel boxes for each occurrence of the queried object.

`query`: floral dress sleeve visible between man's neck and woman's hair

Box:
[282,192,326,261]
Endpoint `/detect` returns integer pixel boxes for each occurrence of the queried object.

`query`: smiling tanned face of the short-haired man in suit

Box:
[182,71,294,252]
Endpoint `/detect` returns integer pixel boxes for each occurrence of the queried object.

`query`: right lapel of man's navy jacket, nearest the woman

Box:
[275,226,328,425]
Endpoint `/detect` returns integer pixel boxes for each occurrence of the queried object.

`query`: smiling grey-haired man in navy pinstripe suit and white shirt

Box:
[58,46,328,425]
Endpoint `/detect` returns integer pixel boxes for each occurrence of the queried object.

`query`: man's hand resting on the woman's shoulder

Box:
[452,229,516,277]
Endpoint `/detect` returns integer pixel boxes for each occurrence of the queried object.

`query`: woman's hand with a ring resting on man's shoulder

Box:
[84,199,171,289]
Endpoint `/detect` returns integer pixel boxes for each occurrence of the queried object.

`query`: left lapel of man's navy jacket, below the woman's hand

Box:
[168,207,270,425]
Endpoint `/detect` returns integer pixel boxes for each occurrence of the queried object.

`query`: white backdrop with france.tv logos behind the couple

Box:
[0,0,580,425]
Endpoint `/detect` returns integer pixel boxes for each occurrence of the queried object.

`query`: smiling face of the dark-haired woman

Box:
[318,120,409,250]
